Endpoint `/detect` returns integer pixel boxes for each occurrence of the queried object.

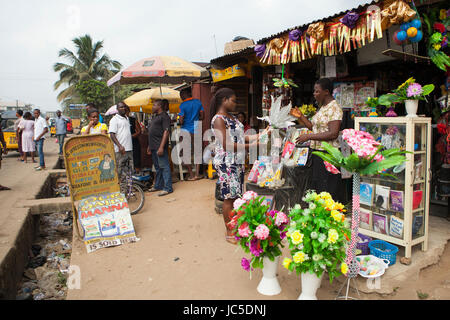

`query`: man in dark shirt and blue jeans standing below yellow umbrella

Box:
[147,100,173,197]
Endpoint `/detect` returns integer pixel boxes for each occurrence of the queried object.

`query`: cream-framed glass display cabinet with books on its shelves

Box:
[355,117,431,258]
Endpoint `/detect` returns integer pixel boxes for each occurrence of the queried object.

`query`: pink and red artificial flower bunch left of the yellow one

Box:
[229,191,289,271]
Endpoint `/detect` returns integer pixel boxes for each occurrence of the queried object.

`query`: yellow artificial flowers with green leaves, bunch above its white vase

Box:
[283,191,351,282]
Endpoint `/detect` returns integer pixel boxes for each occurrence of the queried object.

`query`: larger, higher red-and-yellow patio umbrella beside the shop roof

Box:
[107,56,209,86]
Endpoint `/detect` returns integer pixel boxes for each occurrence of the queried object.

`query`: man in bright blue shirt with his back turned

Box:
[178,88,205,181]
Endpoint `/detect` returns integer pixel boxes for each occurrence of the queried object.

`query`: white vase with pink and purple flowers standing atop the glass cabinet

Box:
[379,77,434,117]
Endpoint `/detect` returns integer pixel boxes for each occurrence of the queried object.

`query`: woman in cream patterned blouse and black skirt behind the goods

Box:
[291,78,343,200]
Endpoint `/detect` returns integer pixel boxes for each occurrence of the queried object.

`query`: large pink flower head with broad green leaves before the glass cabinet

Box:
[313,129,406,176]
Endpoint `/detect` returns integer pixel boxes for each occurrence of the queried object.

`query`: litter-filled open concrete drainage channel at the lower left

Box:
[0,159,73,300]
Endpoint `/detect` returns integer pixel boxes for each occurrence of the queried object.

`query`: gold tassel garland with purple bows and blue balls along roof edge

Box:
[255,0,414,65]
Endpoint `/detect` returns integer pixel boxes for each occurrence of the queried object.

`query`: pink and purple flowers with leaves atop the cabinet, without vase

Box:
[378,77,434,106]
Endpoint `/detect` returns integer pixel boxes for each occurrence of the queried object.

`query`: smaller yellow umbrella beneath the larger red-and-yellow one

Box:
[124,87,182,113]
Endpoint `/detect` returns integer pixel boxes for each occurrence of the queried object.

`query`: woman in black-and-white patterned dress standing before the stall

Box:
[211,88,268,244]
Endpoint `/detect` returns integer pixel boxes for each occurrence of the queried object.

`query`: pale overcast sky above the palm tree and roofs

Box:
[0,0,369,110]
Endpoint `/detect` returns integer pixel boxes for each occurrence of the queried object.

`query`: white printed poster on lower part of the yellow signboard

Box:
[78,192,139,253]
